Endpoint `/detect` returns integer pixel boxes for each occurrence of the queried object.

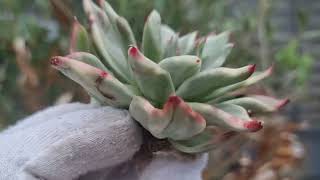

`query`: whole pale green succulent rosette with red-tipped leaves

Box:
[51,0,288,153]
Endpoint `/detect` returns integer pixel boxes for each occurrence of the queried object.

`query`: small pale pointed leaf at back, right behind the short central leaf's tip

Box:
[178,32,197,55]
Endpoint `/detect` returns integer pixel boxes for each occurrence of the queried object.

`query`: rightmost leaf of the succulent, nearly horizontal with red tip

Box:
[223,95,289,114]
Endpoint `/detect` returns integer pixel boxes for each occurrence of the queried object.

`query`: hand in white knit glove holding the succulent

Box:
[0,103,207,180]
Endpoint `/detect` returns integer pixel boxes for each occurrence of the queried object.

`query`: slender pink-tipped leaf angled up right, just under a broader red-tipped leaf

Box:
[205,66,273,104]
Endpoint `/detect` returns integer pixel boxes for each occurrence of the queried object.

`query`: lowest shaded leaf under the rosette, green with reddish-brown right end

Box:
[169,126,238,153]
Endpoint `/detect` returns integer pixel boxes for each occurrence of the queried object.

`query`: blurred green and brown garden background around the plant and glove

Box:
[0,0,320,180]
